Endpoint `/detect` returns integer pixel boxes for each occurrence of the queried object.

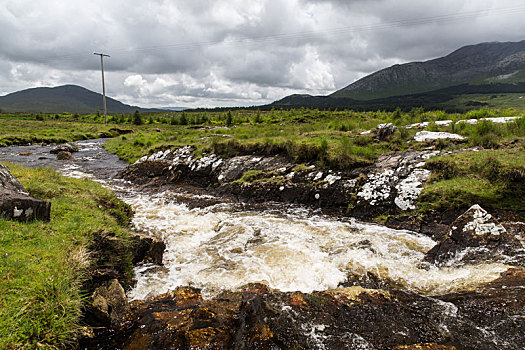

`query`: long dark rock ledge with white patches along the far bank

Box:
[120,147,358,209]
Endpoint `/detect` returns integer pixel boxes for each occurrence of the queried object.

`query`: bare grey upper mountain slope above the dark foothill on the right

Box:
[329,40,525,100]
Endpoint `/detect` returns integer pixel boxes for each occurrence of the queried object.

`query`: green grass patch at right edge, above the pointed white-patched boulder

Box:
[419,146,525,211]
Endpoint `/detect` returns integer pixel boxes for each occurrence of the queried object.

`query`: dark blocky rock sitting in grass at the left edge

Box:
[0,164,51,222]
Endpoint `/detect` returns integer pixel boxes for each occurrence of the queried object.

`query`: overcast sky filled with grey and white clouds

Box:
[0,0,525,107]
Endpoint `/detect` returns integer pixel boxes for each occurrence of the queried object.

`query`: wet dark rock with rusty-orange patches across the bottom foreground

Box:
[81,269,525,350]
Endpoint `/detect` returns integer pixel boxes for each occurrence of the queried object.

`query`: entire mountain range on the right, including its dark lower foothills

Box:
[272,40,525,108]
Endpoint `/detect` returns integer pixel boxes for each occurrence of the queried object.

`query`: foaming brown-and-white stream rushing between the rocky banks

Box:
[0,140,508,299]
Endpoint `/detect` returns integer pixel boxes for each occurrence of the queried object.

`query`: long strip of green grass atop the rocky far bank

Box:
[101,109,422,170]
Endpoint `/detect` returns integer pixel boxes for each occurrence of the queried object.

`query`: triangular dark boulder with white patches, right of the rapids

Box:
[425,204,524,266]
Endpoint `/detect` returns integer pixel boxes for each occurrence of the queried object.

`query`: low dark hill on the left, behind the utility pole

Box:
[0,85,163,114]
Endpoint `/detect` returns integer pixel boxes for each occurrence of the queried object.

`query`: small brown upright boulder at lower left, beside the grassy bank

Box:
[89,279,130,326]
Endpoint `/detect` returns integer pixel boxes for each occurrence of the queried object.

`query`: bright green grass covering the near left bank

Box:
[0,164,135,349]
